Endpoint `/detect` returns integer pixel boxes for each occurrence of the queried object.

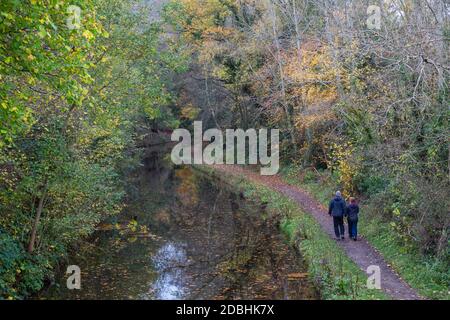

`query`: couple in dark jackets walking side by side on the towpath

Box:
[328,191,359,241]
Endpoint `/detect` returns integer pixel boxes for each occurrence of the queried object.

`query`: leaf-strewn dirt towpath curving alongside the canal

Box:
[214,165,421,300]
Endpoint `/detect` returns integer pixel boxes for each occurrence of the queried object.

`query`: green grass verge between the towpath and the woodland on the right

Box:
[281,167,450,300]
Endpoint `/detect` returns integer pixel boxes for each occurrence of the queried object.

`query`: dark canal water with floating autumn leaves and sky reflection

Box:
[38,148,318,300]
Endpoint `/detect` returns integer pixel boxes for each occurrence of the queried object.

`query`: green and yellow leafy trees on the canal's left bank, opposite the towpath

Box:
[0,0,185,299]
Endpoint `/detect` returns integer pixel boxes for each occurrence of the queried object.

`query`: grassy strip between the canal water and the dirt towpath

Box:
[194,166,391,300]
